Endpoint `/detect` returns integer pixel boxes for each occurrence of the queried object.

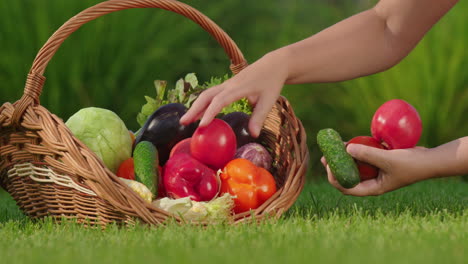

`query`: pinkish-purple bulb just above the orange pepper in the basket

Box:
[234,143,272,170]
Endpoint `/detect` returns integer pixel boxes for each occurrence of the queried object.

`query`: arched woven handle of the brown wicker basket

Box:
[12,0,247,125]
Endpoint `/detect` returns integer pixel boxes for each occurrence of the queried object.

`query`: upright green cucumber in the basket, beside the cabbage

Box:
[133,141,159,195]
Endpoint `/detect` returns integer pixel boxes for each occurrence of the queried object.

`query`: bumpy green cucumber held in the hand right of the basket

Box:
[317,128,360,189]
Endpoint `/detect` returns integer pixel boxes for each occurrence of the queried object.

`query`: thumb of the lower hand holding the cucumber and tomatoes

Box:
[346,144,388,169]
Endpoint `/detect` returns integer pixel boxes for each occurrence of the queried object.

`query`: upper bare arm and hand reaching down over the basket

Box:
[181,0,457,136]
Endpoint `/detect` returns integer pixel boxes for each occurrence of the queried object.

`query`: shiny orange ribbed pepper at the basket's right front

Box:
[220,159,276,213]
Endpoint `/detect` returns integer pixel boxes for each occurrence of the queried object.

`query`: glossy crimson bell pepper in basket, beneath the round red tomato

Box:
[163,153,219,201]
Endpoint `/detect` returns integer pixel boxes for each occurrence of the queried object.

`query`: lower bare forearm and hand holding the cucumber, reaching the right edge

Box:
[322,137,468,196]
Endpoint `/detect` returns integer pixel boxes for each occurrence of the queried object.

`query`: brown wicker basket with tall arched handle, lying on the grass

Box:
[0,0,309,226]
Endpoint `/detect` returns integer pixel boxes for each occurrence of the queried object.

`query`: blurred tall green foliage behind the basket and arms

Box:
[0,0,468,179]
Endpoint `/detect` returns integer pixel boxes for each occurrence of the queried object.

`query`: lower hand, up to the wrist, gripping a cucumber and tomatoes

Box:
[321,144,437,196]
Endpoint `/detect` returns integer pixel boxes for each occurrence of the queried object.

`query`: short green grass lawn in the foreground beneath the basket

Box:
[0,179,468,264]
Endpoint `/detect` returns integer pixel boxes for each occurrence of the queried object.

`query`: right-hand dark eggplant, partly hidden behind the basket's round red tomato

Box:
[221,112,255,148]
